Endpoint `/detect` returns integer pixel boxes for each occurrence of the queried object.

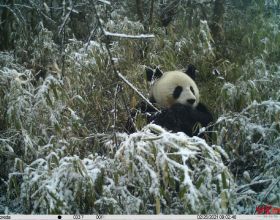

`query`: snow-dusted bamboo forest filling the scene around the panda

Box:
[0,0,280,214]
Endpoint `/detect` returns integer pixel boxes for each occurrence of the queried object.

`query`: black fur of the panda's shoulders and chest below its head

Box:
[149,103,213,136]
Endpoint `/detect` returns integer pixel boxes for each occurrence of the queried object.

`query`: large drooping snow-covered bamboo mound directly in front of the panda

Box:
[111,124,234,213]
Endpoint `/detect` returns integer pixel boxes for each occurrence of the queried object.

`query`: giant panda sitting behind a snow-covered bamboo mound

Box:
[126,65,213,137]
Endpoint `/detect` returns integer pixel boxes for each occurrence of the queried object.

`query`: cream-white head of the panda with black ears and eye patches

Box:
[146,65,199,108]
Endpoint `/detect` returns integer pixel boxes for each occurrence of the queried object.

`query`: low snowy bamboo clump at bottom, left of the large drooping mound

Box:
[21,152,109,214]
